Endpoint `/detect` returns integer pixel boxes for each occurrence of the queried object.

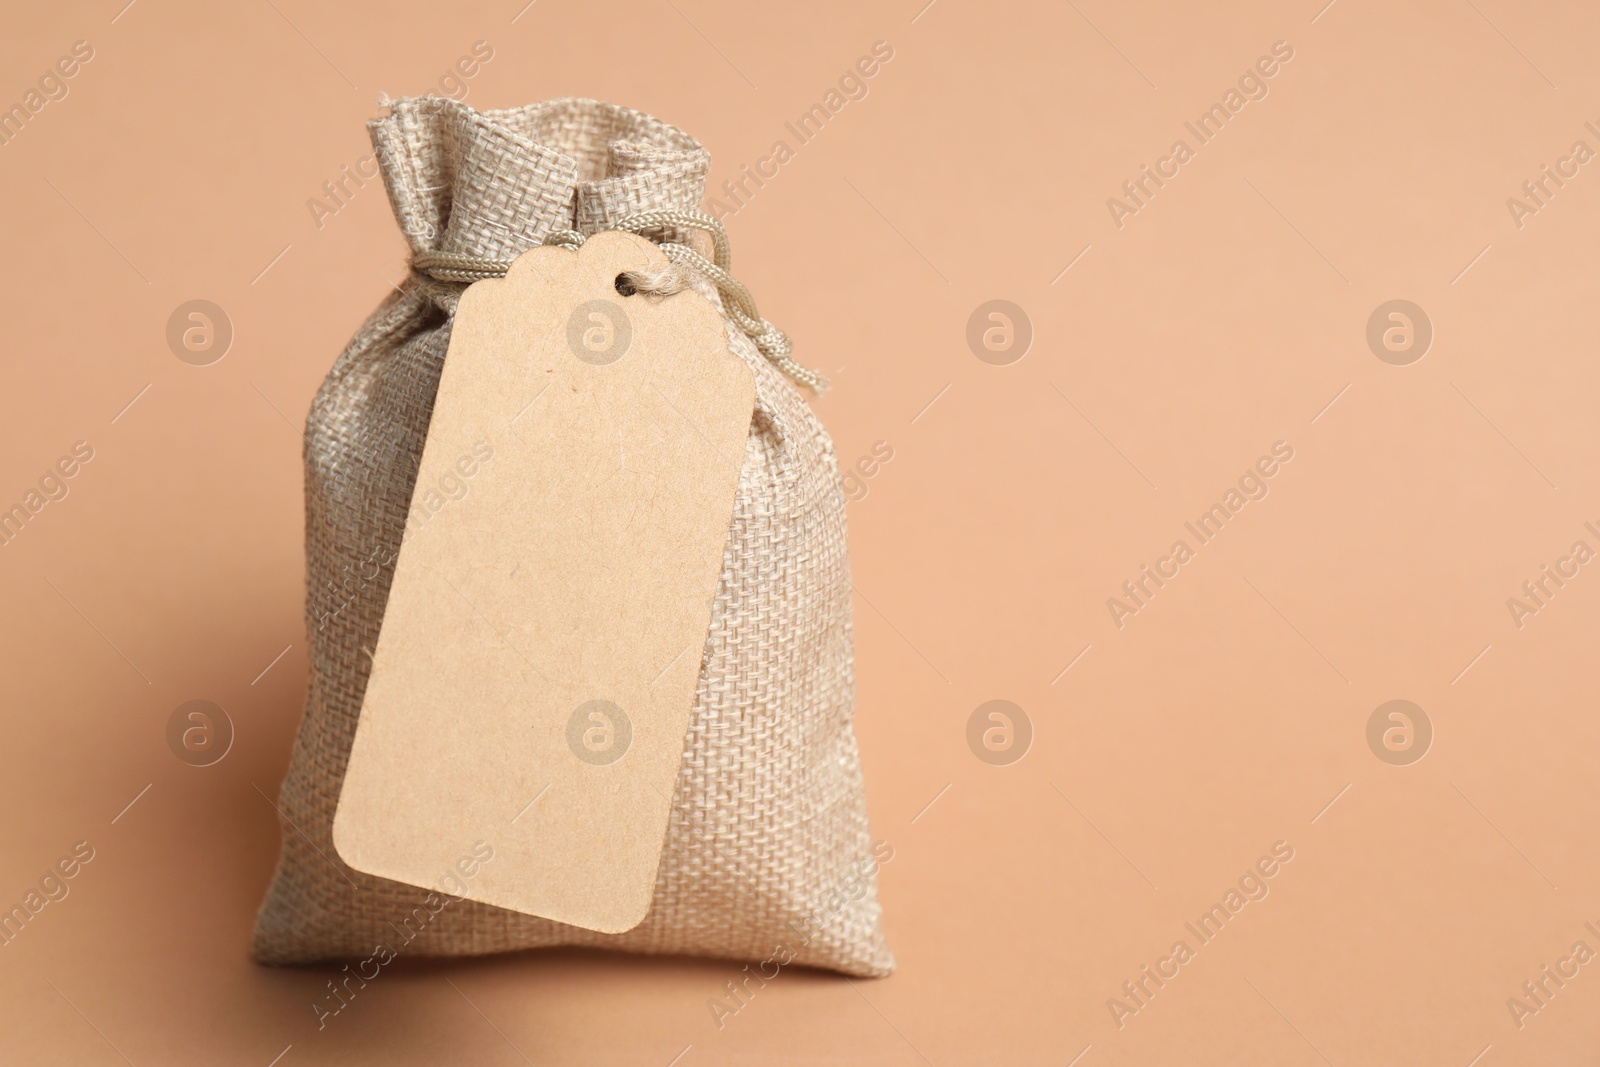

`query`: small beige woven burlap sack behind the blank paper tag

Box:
[254,98,894,976]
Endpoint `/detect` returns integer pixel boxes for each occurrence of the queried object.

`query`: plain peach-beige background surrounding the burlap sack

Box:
[0,0,1600,1067]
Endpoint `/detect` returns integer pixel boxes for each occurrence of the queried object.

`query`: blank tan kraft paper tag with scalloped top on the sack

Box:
[333,232,755,933]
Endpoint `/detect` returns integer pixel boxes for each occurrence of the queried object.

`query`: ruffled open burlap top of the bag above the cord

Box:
[371,96,710,259]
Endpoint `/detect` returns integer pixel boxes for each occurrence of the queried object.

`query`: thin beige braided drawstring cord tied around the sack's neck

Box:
[411,211,827,392]
